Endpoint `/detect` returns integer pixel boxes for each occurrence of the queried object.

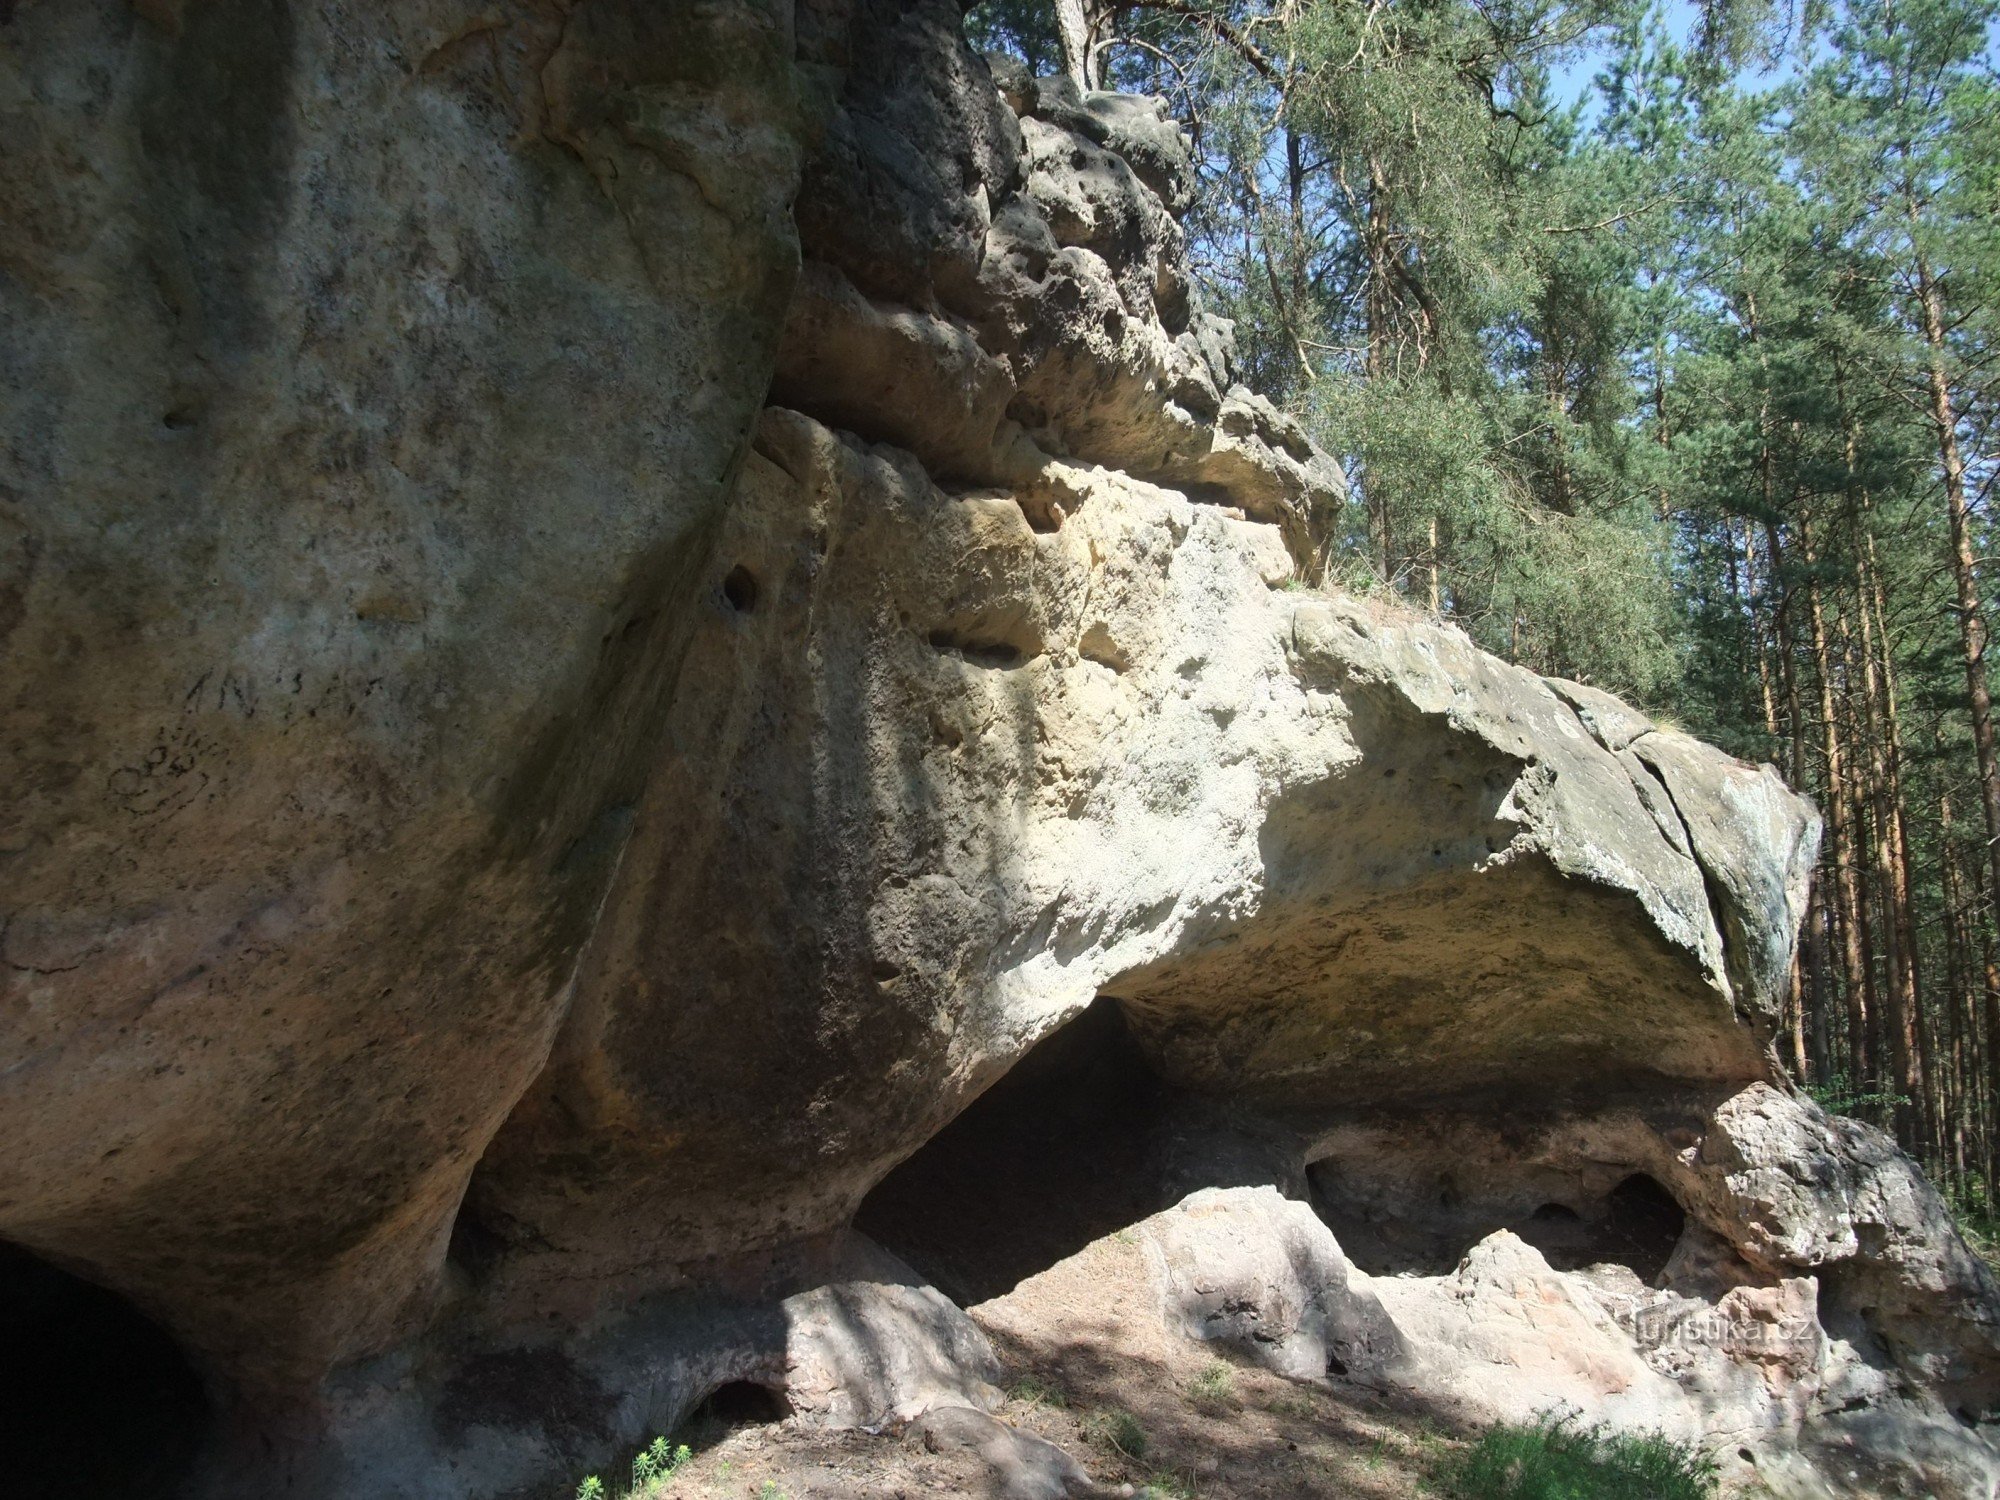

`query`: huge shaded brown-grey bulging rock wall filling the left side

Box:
[0,0,806,1384]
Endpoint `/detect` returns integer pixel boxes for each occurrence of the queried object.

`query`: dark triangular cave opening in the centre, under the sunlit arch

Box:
[854,998,1168,1306]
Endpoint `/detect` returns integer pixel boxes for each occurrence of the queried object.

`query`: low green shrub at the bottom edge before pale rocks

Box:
[1436,1412,1716,1500]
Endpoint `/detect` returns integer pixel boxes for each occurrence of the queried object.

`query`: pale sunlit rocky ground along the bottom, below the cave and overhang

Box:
[572,1188,1992,1500]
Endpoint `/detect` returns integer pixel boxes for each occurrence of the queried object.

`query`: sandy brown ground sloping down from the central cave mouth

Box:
[640,1236,1450,1500]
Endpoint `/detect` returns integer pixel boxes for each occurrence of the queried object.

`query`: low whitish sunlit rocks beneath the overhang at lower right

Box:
[1136,1184,1996,1500]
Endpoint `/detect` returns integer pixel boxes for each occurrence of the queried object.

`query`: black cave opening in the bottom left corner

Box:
[0,1242,208,1496]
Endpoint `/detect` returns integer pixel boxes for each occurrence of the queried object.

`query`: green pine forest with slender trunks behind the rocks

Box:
[968,0,2000,1252]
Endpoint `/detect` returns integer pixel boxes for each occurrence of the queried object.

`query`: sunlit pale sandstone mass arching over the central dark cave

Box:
[466,402,1812,1302]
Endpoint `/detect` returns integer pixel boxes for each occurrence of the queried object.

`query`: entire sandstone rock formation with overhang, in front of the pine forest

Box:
[0,0,2000,1498]
